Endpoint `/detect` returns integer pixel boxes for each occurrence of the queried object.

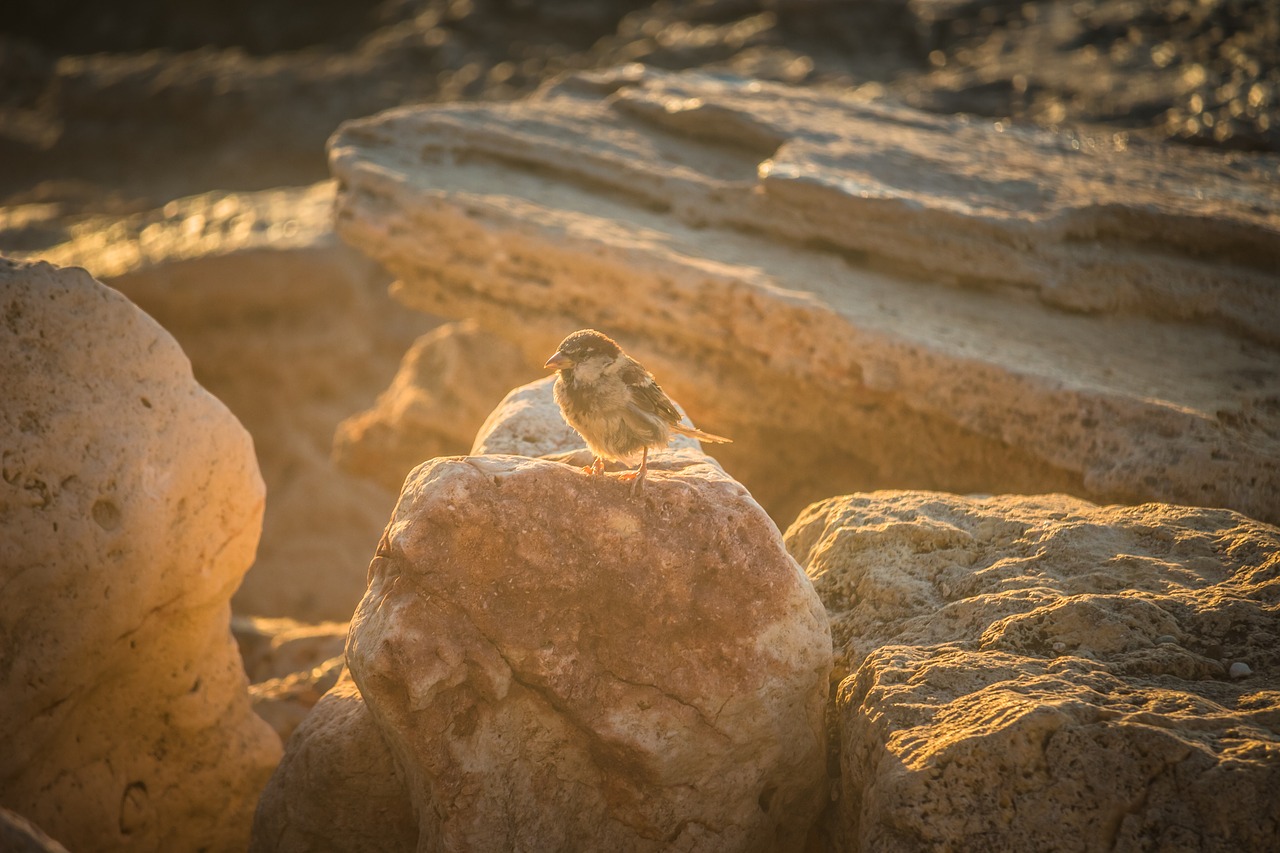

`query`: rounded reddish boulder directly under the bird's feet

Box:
[255,383,831,850]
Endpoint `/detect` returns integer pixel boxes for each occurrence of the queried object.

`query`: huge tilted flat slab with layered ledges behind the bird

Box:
[330,67,1280,521]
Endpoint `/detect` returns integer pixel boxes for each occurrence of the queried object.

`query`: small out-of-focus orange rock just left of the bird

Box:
[333,321,535,492]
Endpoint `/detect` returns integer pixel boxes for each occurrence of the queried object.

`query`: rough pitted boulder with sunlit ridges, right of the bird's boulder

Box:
[786,492,1280,850]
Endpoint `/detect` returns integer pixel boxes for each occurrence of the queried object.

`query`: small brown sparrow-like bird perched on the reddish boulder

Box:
[543,329,732,494]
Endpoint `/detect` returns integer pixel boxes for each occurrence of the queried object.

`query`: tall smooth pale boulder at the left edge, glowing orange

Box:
[0,260,280,850]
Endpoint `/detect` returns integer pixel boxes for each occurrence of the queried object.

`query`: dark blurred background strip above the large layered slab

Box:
[0,0,1280,213]
